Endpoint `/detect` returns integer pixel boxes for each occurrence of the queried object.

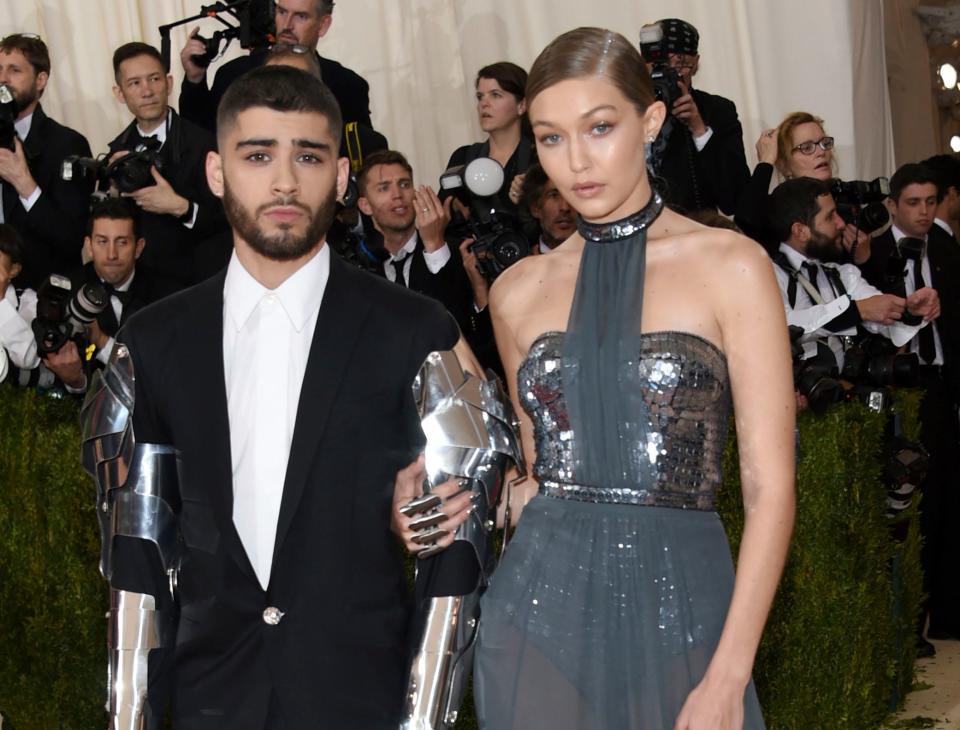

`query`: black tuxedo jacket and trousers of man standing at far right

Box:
[861,225,960,637]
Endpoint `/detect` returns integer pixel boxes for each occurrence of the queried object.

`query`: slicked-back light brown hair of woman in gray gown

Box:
[526,28,656,114]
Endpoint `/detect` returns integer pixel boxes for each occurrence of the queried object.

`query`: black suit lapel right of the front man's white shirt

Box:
[271,252,370,573]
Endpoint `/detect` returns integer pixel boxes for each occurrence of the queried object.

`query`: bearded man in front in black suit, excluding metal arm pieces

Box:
[102,66,469,730]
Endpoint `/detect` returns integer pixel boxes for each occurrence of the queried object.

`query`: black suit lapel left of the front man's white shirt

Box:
[181,271,257,582]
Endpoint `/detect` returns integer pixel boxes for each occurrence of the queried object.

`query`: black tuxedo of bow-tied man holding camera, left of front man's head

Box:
[110,109,227,288]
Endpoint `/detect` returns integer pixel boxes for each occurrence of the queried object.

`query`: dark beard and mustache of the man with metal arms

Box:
[223,180,337,261]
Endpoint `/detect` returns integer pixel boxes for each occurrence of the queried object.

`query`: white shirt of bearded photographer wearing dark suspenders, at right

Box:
[773,243,927,369]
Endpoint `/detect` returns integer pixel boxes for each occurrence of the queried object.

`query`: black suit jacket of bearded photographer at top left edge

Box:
[0,104,93,289]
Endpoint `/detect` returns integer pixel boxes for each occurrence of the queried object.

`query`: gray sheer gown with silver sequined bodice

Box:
[474,203,764,730]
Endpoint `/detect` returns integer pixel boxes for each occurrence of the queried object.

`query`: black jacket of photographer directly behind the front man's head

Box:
[180,51,373,131]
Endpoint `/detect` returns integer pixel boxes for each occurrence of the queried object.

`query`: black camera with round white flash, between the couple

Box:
[439,157,530,281]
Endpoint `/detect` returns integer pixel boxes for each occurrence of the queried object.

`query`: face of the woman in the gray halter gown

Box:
[530,76,666,222]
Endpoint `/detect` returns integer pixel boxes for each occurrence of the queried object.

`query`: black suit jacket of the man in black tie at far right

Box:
[860,225,960,402]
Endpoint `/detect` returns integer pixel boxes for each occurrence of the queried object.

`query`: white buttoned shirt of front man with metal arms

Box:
[223,245,330,590]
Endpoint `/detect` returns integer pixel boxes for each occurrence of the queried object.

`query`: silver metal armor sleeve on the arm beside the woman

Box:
[401,351,524,730]
